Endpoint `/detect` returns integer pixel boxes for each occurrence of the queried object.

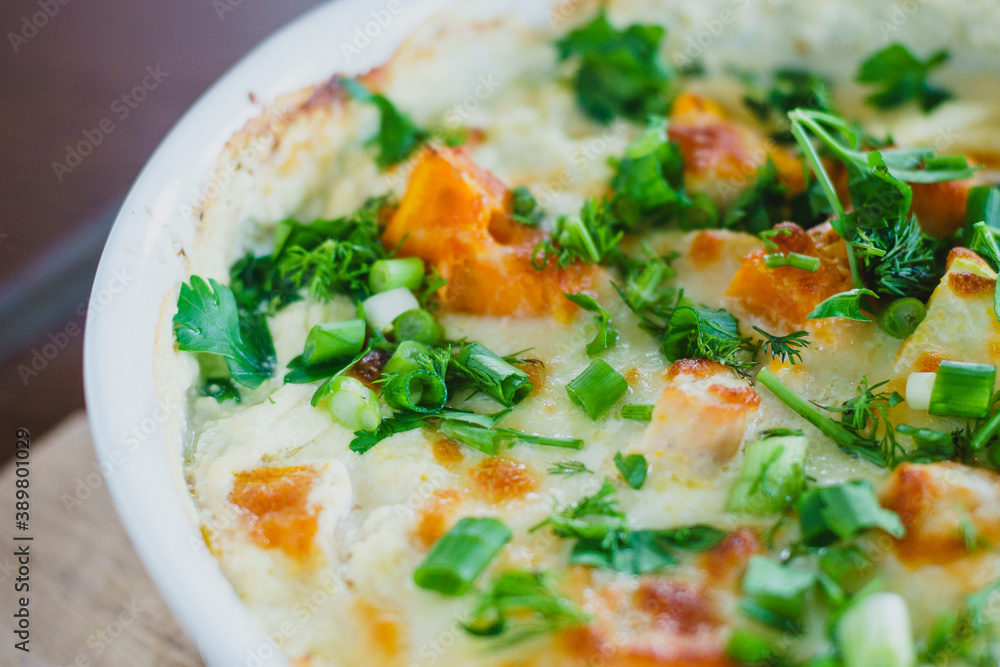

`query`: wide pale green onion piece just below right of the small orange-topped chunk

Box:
[728,435,808,515]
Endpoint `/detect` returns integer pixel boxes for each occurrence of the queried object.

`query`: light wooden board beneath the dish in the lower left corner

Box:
[0,412,204,667]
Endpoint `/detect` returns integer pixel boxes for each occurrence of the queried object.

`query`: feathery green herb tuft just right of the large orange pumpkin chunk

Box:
[531,199,624,271]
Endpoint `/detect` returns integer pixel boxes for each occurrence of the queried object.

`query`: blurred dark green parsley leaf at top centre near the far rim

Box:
[556,9,674,123]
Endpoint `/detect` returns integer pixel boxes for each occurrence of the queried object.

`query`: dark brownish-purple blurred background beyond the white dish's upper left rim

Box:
[0,0,321,460]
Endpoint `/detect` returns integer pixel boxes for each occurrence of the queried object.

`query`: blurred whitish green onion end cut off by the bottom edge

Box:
[835,593,917,667]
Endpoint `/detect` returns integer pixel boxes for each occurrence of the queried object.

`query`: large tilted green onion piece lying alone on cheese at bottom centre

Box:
[413,517,511,595]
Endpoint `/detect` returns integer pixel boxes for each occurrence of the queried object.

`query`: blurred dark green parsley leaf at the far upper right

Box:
[856,44,951,111]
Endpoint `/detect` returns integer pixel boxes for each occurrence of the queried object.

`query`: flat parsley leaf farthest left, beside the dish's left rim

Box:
[174,276,275,389]
